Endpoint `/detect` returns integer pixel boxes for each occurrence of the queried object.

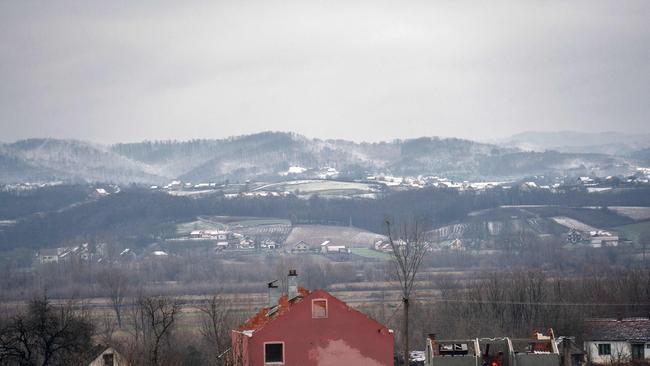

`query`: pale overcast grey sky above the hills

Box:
[0,0,650,143]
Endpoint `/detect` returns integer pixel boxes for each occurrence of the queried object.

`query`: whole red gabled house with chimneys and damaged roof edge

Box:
[231,270,394,366]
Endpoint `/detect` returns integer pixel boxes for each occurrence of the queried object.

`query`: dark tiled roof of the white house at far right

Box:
[584,318,650,341]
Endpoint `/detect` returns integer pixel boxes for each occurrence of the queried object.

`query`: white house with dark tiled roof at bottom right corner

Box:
[584,318,650,364]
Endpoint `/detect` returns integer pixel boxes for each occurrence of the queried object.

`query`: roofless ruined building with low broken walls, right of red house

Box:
[425,329,560,366]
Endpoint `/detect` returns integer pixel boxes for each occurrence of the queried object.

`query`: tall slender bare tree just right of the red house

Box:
[386,220,427,365]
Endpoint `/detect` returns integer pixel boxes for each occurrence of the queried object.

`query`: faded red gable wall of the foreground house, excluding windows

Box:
[246,290,394,366]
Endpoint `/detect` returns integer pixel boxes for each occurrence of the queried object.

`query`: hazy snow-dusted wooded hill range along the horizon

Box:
[0,132,647,184]
